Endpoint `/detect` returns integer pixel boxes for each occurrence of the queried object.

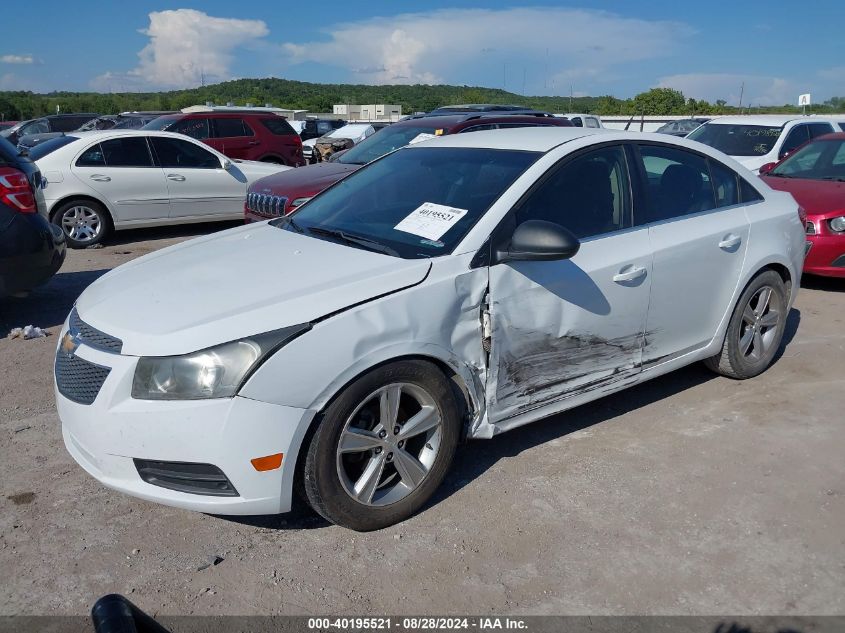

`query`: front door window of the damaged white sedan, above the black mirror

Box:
[515,145,631,239]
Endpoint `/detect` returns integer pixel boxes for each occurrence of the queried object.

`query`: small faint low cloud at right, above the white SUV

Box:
[658,73,807,106]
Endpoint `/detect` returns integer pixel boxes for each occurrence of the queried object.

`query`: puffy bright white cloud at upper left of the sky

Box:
[92,9,270,90]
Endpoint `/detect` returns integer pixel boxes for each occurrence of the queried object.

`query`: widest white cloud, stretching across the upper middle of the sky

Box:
[283,7,693,84]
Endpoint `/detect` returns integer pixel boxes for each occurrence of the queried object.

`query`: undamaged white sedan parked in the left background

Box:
[30,130,290,248]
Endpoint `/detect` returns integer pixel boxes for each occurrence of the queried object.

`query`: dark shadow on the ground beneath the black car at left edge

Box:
[0,268,109,338]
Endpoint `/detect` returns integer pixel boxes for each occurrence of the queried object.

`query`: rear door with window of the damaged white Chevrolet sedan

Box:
[635,144,749,367]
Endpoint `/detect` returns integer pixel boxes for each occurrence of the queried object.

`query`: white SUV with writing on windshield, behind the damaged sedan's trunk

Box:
[687,114,845,171]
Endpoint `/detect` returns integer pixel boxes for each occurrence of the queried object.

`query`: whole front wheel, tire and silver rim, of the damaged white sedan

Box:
[303,360,460,531]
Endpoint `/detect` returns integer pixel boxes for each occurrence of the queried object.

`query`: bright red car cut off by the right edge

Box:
[760,132,845,277]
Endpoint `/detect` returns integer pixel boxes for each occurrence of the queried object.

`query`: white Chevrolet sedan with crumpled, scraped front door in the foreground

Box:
[55,128,804,530]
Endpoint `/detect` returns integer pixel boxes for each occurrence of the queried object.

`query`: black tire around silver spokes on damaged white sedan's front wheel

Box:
[303,360,461,532]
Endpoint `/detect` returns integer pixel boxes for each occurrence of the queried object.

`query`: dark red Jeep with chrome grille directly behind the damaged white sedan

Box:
[244,112,572,223]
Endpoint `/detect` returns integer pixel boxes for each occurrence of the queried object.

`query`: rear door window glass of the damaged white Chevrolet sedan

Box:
[639,145,716,223]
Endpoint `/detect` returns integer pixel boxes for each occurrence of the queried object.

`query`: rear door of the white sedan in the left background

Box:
[71,136,170,223]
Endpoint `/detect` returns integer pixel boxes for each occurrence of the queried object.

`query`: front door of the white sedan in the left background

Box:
[150,136,247,220]
